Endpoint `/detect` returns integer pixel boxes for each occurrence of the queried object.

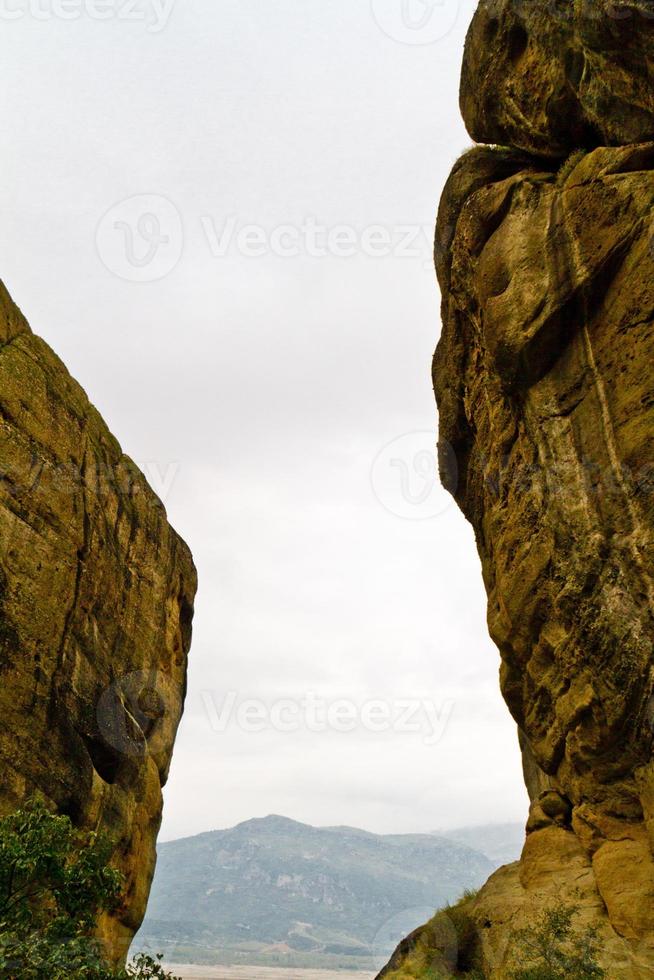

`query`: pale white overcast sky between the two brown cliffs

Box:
[0,0,526,838]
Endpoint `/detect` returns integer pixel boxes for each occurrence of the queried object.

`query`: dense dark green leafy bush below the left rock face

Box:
[0,801,178,980]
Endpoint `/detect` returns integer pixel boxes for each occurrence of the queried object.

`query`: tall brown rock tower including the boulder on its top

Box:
[383,0,654,980]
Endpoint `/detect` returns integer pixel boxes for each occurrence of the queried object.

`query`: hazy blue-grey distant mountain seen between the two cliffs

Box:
[138,816,494,962]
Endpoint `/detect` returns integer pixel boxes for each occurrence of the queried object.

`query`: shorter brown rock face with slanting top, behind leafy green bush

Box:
[0,287,196,961]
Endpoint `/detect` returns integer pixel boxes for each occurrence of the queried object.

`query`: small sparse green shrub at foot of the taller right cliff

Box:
[509,903,606,980]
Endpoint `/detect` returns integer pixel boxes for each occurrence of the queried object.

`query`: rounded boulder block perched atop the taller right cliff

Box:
[461,0,654,157]
